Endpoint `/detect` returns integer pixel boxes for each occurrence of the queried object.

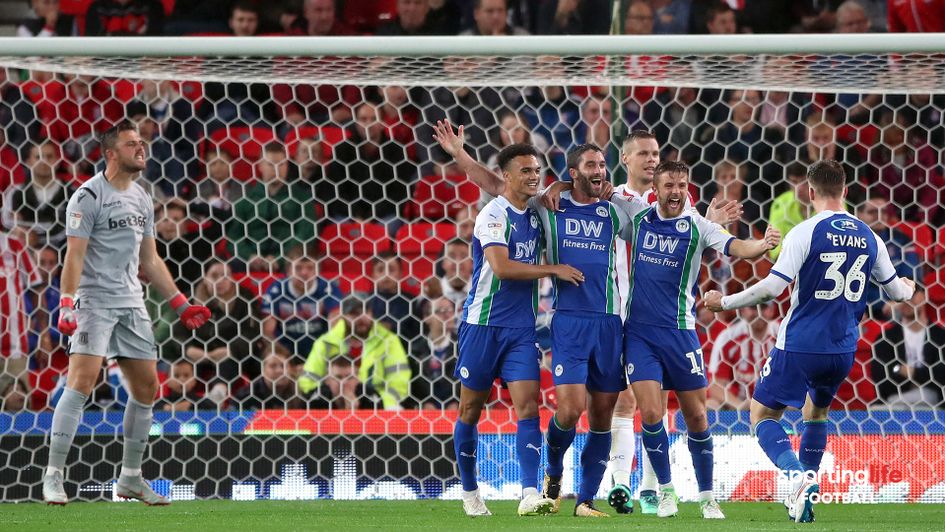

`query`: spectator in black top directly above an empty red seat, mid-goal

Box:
[319,102,412,222]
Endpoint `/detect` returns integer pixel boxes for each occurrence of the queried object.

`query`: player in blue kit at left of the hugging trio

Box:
[437,135,584,516]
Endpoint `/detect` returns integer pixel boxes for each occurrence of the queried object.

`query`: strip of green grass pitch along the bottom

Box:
[0,500,945,532]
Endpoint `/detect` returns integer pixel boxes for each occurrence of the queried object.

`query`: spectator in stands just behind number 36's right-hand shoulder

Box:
[856,197,923,321]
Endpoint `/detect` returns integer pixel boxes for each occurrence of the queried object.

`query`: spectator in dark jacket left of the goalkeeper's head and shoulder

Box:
[8,140,72,246]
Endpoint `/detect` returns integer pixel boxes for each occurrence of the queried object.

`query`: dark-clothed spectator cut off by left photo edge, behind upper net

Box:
[0,67,43,152]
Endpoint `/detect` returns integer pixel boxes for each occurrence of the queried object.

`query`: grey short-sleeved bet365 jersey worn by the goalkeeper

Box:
[66,172,154,309]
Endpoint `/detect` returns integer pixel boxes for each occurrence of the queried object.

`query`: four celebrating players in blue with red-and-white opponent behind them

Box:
[435,118,915,522]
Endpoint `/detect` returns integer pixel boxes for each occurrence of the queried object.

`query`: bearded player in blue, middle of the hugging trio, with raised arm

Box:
[437,118,645,517]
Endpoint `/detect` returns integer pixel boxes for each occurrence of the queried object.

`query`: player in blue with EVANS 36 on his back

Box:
[704,160,915,523]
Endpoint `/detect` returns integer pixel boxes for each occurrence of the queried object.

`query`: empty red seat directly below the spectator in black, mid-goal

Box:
[319,222,391,293]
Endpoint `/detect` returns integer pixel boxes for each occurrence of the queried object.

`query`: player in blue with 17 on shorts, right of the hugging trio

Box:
[612,161,780,519]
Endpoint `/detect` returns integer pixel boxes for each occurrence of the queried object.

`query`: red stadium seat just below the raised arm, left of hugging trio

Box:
[404,175,479,220]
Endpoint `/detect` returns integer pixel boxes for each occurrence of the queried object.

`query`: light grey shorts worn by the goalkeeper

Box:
[69,308,157,360]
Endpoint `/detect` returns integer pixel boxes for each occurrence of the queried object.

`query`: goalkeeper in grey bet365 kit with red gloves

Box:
[43,121,210,505]
